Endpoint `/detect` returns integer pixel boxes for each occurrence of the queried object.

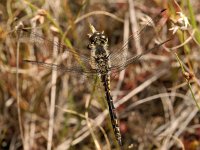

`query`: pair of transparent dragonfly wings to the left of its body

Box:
[13,29,97,74]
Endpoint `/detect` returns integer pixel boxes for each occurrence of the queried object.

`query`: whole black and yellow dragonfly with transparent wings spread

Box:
[14,10,171,146]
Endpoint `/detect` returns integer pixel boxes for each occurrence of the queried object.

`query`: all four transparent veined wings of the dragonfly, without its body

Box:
[20,11,168,74]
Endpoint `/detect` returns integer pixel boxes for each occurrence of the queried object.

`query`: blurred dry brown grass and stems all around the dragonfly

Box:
[0,0,200,150]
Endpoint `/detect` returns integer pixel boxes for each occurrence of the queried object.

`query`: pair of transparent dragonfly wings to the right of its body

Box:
[109,10,165,70]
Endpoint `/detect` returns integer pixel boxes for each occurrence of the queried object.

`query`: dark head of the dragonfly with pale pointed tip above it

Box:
[88,25,108,50]
